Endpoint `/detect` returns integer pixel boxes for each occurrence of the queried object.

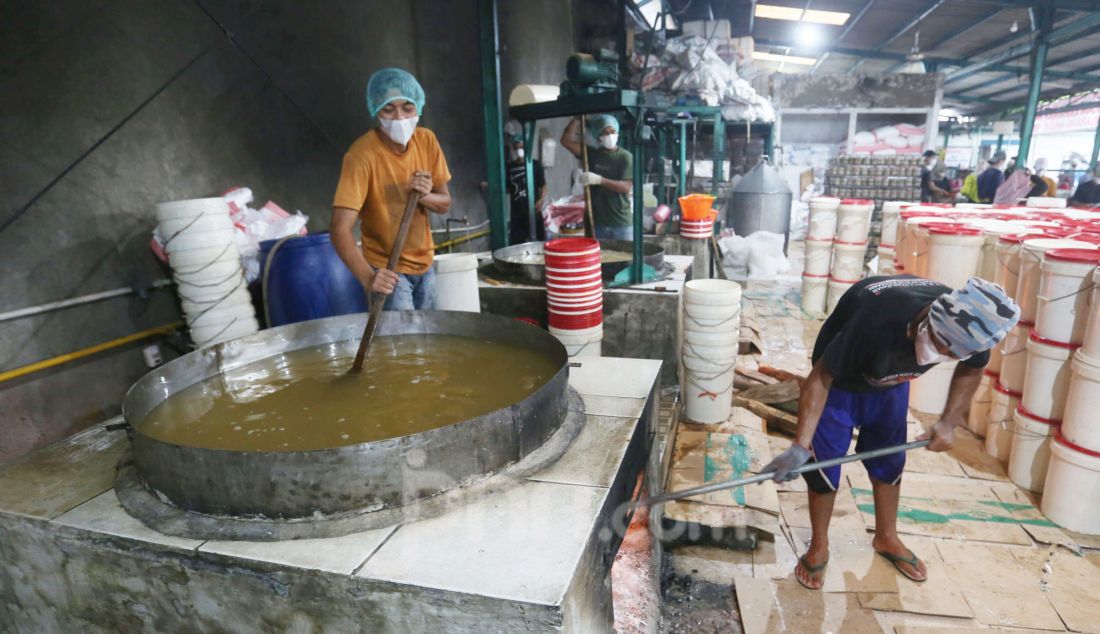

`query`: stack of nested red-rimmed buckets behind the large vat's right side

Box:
[546,238,604,356]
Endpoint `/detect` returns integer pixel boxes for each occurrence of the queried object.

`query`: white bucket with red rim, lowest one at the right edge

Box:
[1040,434,1100,535]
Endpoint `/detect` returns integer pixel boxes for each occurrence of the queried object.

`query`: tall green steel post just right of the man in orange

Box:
[477,0,512,250]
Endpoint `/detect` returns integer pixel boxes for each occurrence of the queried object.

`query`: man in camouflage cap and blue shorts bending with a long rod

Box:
[763,275,1020,590]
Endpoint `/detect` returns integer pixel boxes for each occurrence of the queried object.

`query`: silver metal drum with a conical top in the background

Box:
[726,157,793,254]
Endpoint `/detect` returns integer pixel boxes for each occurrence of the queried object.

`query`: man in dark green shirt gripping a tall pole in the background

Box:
[561,114,634,240]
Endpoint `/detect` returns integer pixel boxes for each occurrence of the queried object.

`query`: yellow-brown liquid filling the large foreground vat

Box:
[140,335,557,451]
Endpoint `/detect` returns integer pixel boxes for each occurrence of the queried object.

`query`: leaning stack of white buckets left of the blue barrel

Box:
[156,198,260,348]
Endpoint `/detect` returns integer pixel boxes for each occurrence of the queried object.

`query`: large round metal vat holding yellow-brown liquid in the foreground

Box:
[122,310,569,518]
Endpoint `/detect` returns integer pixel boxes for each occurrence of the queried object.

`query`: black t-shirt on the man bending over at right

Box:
[813,275,989,392]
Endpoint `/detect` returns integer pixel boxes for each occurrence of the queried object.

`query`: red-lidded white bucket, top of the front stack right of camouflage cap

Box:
[1035,249,1100,343]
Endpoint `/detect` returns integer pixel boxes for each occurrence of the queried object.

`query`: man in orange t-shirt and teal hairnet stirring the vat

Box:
[331,68,451,310]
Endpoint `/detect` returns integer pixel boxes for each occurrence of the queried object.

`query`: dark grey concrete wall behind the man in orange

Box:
[0,0,572,462]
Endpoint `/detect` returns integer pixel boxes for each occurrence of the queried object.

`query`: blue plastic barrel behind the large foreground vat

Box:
[260,232,366,327]
